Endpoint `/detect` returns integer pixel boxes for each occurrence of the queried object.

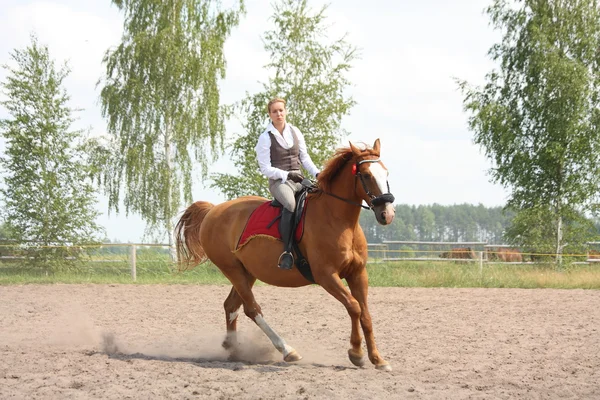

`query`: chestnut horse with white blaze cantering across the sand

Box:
[175,139,395,370]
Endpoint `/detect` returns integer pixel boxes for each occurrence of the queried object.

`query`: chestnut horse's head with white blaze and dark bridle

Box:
[350,139,396,225]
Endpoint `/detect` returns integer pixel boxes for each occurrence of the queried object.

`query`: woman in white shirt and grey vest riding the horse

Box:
[255,98,319,269]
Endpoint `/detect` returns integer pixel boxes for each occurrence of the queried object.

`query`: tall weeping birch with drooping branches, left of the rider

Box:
[95,0,244,244]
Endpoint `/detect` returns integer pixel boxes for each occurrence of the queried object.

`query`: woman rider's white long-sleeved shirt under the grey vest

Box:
[254,122,319,183]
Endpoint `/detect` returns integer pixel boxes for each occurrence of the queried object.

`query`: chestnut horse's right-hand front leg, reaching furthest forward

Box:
[346,268,392,371]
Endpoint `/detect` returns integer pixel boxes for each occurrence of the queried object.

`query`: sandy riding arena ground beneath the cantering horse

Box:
[0,285,600,400]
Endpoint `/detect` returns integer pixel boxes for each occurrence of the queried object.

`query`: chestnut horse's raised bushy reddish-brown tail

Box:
[175,201,214,271]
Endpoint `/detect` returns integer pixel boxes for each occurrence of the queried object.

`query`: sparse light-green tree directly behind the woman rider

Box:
[211,0,357,198]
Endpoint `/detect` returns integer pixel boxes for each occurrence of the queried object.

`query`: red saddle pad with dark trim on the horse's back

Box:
[237,199,308,249]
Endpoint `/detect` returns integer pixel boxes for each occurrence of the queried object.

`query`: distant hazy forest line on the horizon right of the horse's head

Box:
[360,204,514,244]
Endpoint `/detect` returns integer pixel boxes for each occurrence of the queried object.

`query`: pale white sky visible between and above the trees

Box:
[0,0,508,243]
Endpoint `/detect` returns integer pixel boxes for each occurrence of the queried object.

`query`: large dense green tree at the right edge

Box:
[460,0,600,263]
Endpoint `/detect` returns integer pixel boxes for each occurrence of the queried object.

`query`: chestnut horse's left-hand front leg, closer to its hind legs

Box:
[319,274,365,367]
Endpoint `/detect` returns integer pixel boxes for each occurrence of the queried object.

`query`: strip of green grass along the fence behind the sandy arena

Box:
[0,252,600,289]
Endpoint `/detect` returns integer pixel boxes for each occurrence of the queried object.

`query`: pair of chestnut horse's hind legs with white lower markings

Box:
[221,268,302,362]
